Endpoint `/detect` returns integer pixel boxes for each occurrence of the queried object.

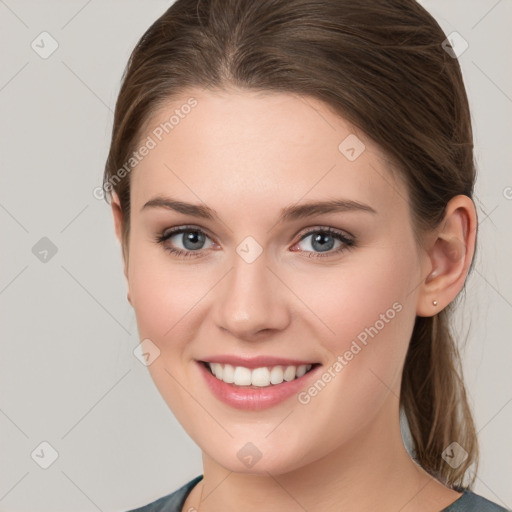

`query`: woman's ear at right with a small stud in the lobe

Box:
[416,195,477,316]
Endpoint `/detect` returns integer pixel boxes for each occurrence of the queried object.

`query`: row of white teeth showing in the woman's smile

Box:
[208,363,313,387]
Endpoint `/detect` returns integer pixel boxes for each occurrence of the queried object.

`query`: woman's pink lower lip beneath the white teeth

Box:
[196,361,320,411]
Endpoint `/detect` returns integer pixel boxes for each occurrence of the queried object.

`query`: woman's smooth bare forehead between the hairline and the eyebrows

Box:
[131,89,407,222]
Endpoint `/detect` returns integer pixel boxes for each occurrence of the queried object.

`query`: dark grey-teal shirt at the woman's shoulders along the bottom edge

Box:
[128,475,510,512]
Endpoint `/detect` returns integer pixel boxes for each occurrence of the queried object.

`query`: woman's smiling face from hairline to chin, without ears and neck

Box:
[116,90,424,474]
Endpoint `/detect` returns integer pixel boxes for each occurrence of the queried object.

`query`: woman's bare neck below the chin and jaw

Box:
[187,394,458,512]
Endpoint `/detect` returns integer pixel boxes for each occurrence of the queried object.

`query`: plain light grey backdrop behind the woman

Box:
[0,0,512,512]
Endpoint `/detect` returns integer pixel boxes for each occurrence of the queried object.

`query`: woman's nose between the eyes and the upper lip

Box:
[214,251,291,341]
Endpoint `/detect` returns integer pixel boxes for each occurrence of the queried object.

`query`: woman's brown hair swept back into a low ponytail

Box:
[104,0,478,488]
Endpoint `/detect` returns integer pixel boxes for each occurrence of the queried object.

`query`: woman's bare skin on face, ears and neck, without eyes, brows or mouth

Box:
[112,89,476,512]
